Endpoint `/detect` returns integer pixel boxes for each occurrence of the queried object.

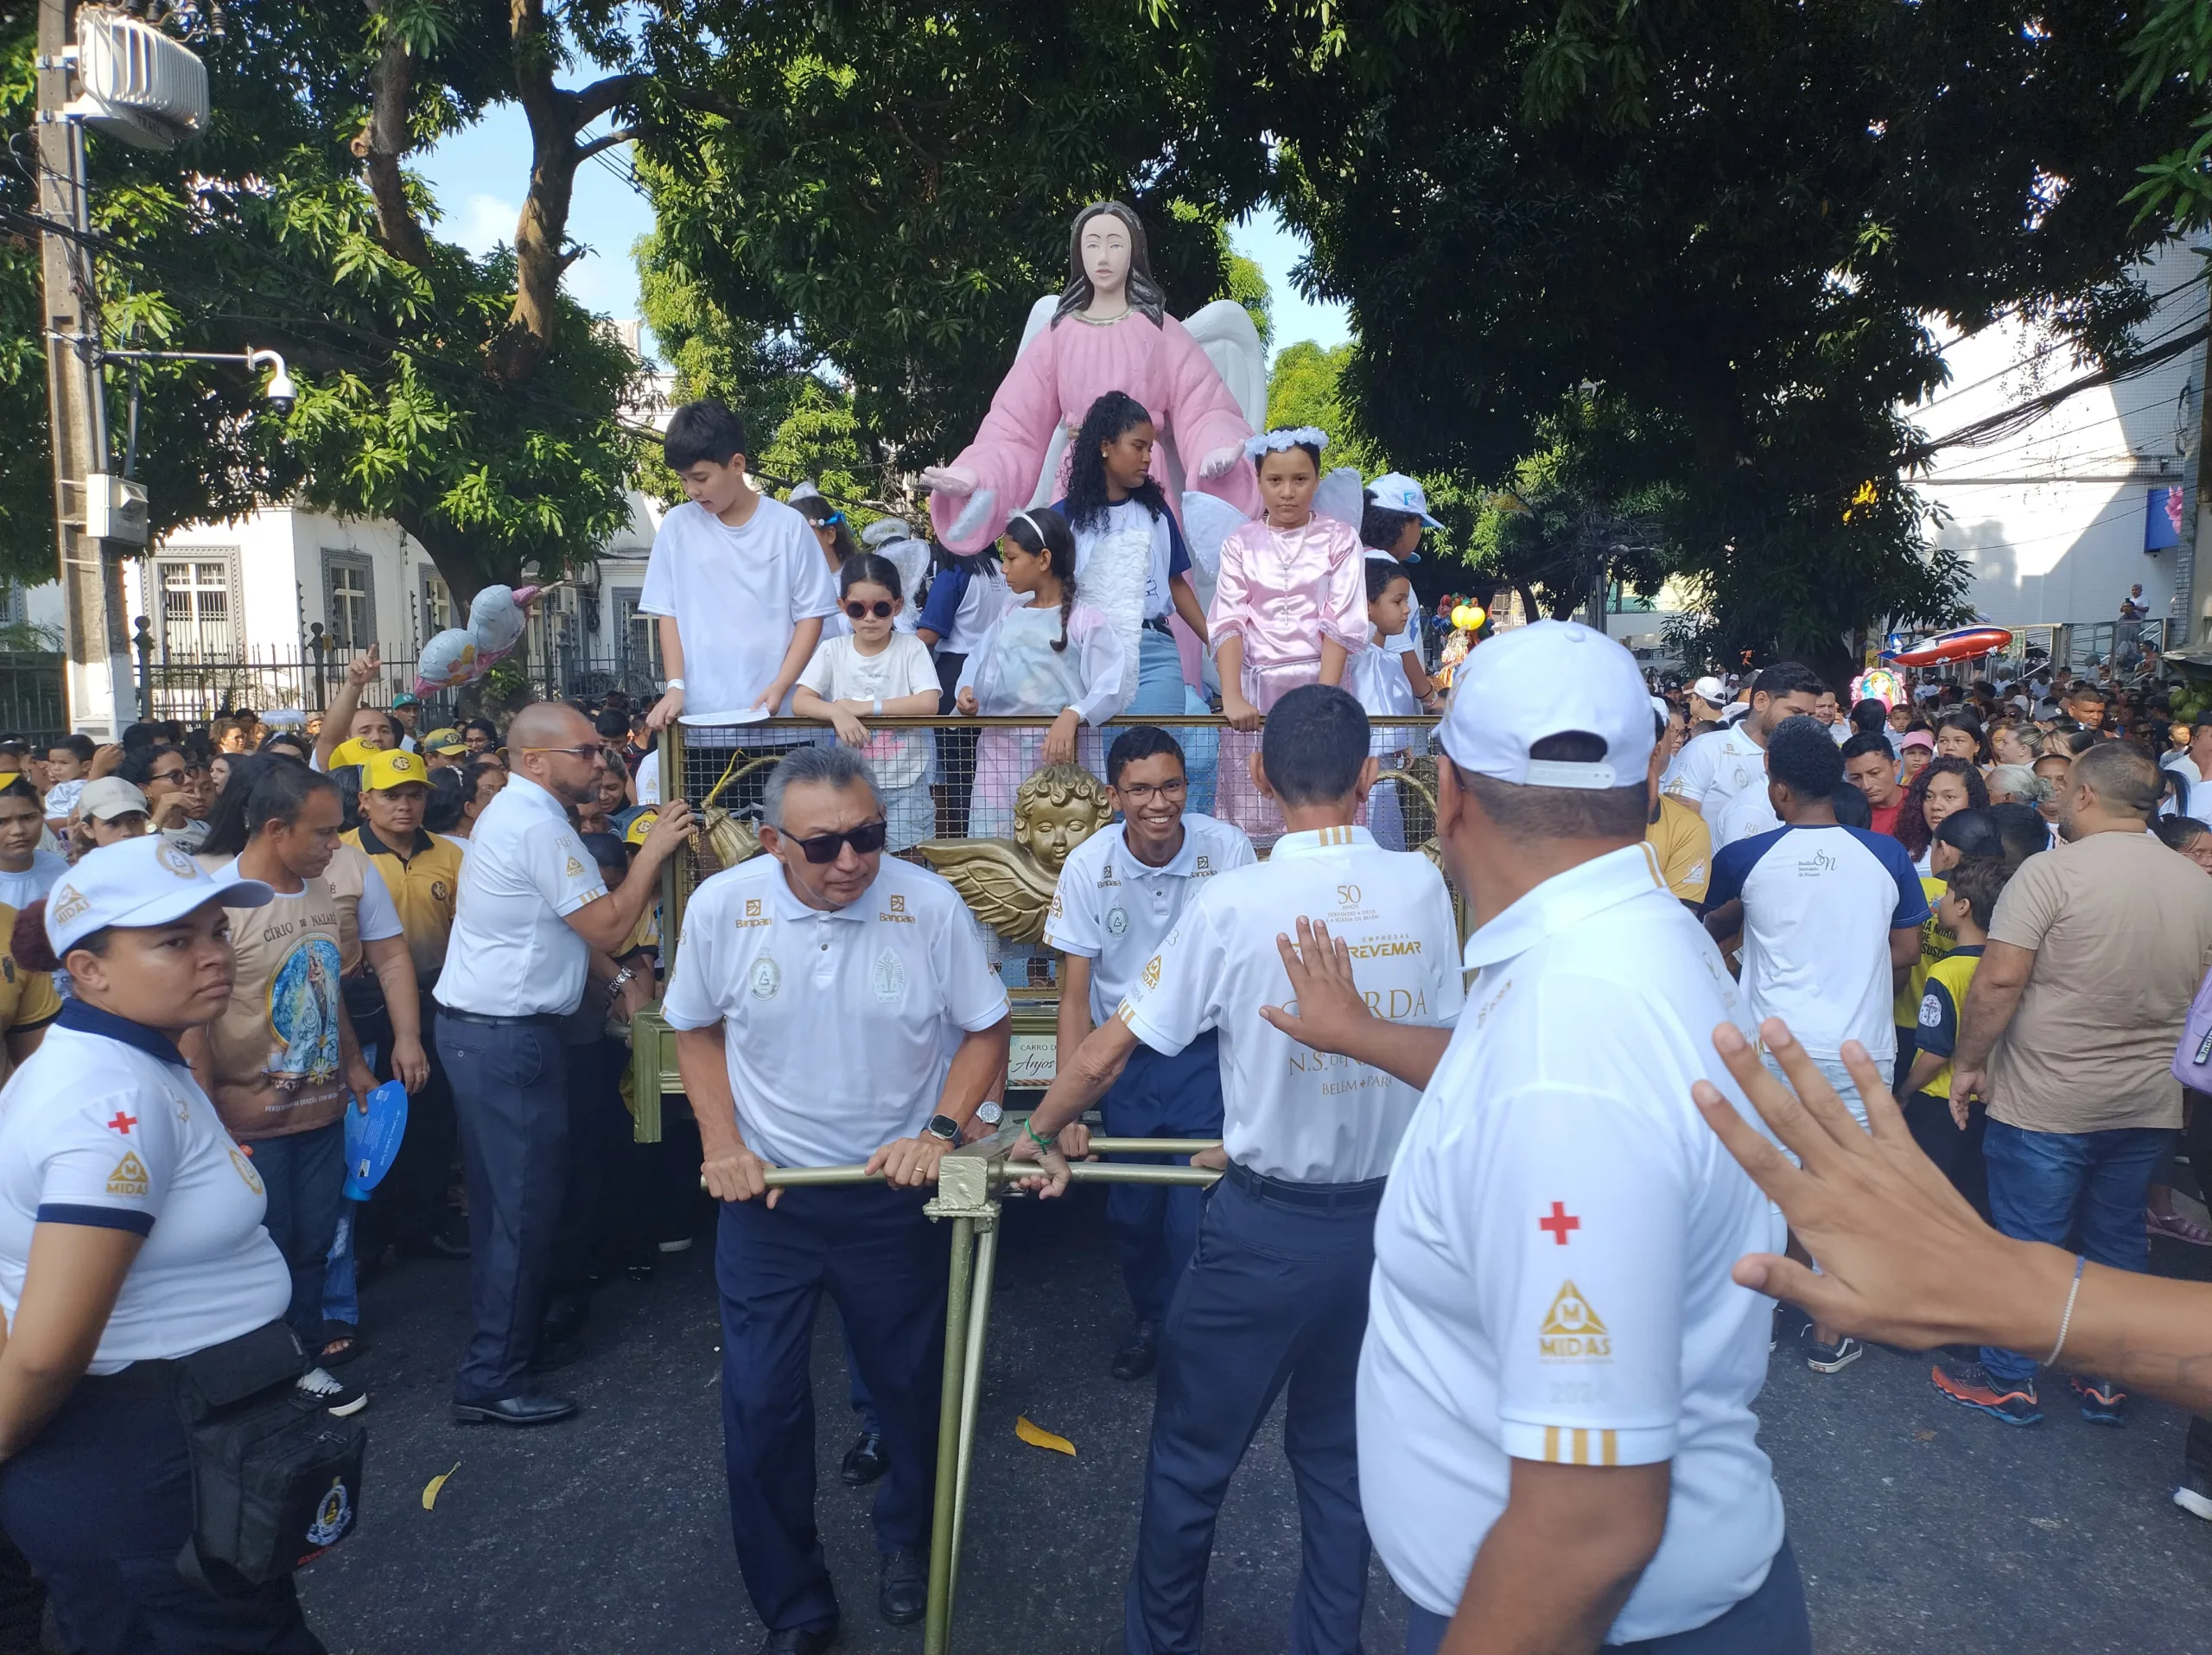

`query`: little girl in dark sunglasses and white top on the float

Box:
[791,551,938,850]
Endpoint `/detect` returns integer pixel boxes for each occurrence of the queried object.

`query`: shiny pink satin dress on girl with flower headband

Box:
[1205,513,1367,845]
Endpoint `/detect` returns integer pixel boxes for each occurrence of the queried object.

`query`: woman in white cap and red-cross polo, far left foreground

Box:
[0,834,336,1655]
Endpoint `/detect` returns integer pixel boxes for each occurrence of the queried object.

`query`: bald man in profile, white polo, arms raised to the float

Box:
[435,702,692,1425]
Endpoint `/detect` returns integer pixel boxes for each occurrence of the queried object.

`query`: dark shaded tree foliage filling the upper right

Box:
[1208,0,2195,671]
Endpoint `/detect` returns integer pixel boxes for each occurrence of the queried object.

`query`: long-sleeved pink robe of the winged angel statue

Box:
[929,309,1259,553]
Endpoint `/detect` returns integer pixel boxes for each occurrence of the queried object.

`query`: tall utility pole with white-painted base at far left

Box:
[38,0,137,739]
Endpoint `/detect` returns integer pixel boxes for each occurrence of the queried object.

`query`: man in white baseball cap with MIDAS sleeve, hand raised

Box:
[1265,621,1812,1655]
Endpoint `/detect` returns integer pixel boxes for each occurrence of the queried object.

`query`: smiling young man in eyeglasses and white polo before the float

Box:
[1044,723,1255,1378]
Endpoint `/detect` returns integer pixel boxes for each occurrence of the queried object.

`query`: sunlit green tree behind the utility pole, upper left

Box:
[0,0,639,600]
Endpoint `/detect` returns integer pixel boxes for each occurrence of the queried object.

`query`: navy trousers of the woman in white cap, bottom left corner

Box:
[0,1380,323,1655]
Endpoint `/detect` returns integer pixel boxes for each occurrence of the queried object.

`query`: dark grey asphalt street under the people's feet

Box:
[301,1190,2212,1655]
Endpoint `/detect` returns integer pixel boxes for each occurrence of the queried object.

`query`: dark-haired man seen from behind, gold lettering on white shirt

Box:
[1015,681,1459,1655]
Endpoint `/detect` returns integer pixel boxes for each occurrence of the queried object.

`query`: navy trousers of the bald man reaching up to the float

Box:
[438,1018,569,1403]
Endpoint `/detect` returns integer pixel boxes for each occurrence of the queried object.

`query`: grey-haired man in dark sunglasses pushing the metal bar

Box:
[654,746,1013,1655]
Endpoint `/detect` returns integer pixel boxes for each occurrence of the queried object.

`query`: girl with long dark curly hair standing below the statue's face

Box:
[1053,391,1205,712]
